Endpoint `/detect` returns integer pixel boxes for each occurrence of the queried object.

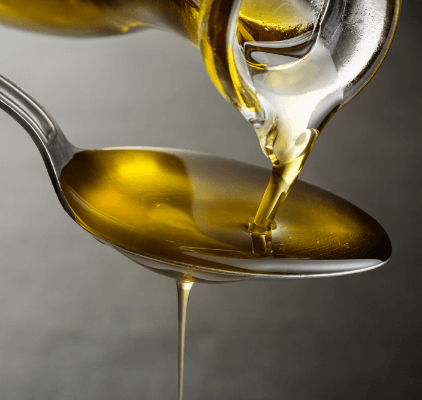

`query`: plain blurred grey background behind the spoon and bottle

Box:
[0,1,422,400]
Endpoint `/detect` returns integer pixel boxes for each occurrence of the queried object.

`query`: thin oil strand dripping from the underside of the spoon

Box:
[176,279,193,400]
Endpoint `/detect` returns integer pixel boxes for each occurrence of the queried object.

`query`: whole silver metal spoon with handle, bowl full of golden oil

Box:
[0,76,391,282]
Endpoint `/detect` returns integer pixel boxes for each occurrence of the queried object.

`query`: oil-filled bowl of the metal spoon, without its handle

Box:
[60,147,391,281]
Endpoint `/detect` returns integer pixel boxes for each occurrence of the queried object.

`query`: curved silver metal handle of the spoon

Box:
[0,75,78,218]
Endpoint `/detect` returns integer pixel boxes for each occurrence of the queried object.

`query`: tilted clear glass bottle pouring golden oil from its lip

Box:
[0,0,401,166]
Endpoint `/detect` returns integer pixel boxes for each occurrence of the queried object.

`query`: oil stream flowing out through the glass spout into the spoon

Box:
[237,1,343,255]
